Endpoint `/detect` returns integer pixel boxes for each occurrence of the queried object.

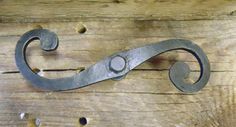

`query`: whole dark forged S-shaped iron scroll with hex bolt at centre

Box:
[15,29,210,92]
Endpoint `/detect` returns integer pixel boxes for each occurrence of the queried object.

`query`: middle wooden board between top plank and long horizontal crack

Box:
[0,20,236,72]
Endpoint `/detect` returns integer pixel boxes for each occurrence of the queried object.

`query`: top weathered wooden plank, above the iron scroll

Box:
[0,0,236,22]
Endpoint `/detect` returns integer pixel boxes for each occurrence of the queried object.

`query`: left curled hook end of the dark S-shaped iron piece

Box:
[15,29,74,90]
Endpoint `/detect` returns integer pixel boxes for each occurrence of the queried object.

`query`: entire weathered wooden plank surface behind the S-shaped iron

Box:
[0,0,236,127]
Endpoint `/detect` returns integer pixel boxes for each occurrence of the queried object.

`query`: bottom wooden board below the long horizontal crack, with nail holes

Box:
[0,71,236,127]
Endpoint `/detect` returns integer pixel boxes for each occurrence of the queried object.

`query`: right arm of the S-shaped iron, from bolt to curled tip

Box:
[125,39,210,92]
